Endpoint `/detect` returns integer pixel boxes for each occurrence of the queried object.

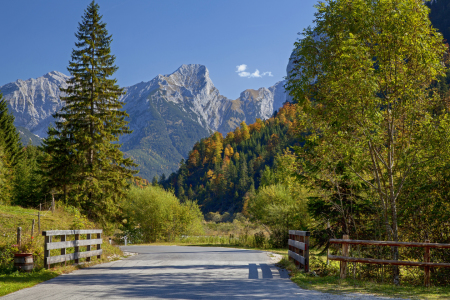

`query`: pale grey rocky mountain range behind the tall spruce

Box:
[0,64,286,180]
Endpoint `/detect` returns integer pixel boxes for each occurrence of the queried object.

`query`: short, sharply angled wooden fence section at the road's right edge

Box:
[288,230,310,272]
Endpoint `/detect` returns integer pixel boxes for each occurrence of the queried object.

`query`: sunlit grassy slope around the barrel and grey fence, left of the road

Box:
[0,205,123,297]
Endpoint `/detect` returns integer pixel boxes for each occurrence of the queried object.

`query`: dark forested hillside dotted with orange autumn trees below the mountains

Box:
[160,103,297,213]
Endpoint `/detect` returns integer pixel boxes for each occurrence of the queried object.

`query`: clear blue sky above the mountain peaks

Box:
[0,0,318,99]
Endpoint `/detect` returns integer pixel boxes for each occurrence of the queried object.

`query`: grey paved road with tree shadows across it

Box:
[2,246,400,300]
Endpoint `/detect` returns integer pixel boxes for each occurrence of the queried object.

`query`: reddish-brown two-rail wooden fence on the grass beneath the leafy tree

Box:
[328,235,450,287]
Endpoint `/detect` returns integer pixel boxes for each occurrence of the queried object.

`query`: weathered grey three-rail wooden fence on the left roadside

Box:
[42,229,103,269]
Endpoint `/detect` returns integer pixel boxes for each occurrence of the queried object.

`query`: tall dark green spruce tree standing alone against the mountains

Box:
[44,1,137,220]
